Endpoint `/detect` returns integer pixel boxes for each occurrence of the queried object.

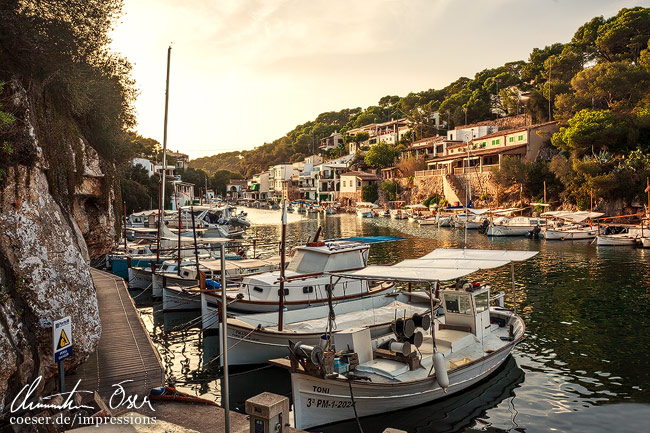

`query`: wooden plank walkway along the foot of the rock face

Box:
[77,269,165,398]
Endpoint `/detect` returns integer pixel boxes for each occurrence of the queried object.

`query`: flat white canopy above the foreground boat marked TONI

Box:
[336,248,538,282]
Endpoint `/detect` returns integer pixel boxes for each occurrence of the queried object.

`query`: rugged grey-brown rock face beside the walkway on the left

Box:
[0,82,115,412]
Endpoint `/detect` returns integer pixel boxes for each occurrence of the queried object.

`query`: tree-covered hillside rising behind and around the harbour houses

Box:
[193,7,650,208]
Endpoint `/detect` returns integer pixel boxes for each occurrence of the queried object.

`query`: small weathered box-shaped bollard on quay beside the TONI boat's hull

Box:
[246,392,289,433]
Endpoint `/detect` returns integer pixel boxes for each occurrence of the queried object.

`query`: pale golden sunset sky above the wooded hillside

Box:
[112,0,650,158]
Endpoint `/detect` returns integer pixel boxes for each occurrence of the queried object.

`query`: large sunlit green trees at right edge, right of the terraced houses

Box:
[497,8,650,209]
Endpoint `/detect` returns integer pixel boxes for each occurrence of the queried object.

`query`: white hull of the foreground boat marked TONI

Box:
[291,344,514,429]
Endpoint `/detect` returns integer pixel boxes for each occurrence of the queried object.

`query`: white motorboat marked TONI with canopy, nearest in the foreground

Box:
[271,249,537,429]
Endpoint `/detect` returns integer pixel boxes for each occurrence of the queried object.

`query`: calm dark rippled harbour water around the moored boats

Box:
[136,211,650,433]
